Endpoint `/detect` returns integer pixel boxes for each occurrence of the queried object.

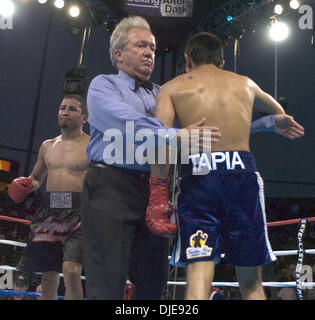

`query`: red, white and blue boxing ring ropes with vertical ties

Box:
[0,215,315,300]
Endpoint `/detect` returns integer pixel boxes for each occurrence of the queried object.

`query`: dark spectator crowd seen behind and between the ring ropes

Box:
[0,190,315,300]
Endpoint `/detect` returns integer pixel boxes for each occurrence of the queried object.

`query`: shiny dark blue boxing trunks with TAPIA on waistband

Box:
[171,151,276,267]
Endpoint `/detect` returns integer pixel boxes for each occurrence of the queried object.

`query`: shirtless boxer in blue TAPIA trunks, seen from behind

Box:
[147,32,304,300]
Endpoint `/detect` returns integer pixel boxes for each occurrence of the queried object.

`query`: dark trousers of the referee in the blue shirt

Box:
[81,163,168,300]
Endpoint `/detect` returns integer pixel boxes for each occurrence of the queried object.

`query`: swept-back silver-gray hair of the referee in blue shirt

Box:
[109,16,152,68]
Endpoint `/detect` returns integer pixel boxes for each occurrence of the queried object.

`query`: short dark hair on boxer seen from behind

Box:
[185,32,223,67]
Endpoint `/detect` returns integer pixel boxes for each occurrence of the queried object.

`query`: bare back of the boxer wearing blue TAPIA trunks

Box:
[157,65,255,151]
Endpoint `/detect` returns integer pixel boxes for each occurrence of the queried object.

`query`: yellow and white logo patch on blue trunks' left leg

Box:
[186,230,213,259]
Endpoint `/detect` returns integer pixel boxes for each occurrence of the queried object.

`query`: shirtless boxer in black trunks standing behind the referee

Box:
[9,95,89,300]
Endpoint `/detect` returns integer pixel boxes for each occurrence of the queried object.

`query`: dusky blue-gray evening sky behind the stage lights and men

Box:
[0,1,315,198]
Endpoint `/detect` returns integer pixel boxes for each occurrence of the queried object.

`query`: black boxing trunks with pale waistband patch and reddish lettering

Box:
[17,192,83,272]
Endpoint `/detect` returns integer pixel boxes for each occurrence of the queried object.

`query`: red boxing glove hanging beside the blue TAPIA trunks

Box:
[145,176,177,238]
